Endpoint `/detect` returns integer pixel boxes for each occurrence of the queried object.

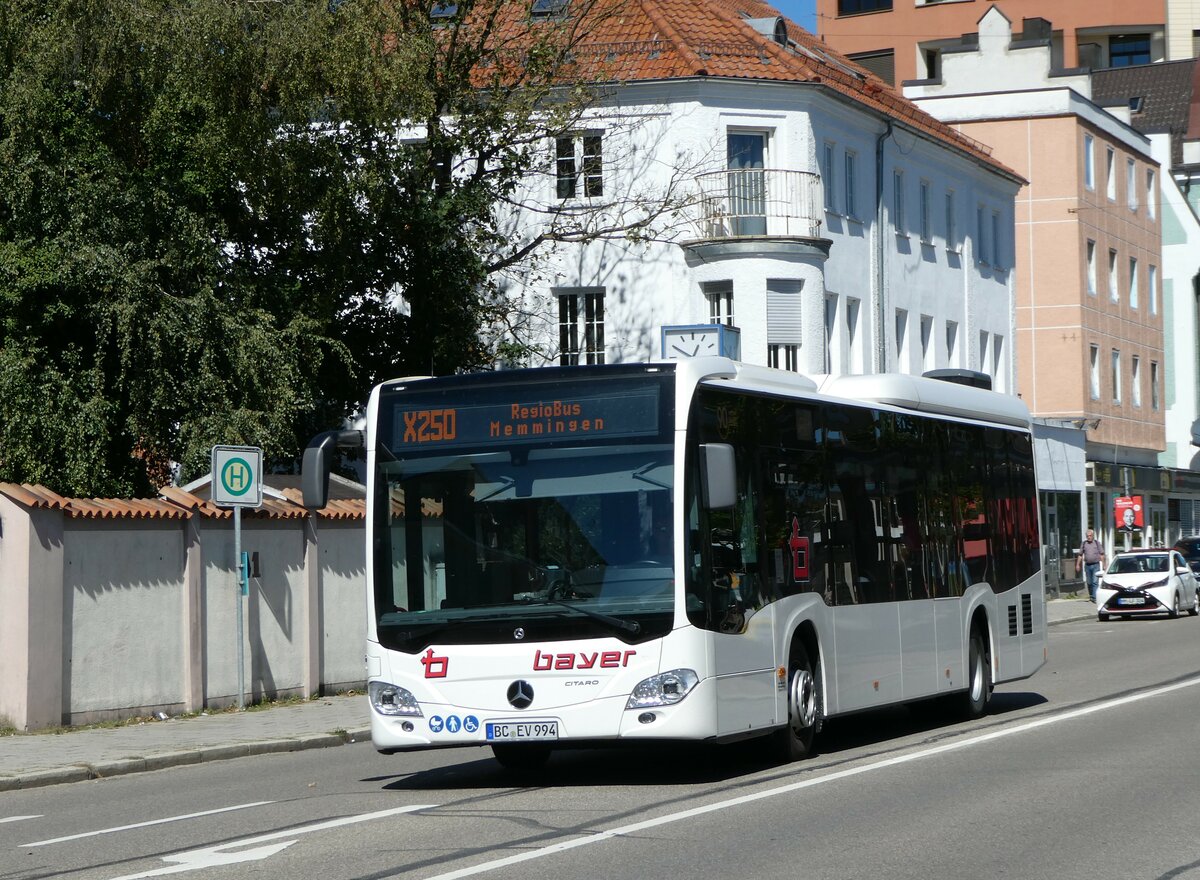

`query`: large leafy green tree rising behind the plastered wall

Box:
[0,0,696,496]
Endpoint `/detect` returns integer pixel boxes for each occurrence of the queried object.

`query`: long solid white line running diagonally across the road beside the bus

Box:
[427,677,1200,880]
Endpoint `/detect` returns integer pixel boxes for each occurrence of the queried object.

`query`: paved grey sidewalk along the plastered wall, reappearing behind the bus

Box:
[0,598,1096,791]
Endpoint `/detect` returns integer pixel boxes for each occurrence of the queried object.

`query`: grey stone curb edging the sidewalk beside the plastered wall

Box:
[0,728,371,791]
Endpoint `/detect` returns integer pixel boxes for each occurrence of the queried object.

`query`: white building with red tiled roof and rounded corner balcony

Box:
[494,0,1024,391]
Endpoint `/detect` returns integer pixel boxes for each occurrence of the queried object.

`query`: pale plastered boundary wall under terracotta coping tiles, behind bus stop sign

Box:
[0,492,366,730]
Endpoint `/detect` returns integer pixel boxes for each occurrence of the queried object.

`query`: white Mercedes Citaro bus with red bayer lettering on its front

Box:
[305,358,1046,767]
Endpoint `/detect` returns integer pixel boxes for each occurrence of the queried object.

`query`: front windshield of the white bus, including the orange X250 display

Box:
[373,367,674,653]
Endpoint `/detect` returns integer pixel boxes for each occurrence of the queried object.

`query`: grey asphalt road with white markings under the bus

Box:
[0,609,1200,880]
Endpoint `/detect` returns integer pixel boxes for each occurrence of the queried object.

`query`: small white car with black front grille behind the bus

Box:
[1096,547,1200,621]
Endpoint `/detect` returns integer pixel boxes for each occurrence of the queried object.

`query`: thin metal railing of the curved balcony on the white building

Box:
[696,168,824,240]
